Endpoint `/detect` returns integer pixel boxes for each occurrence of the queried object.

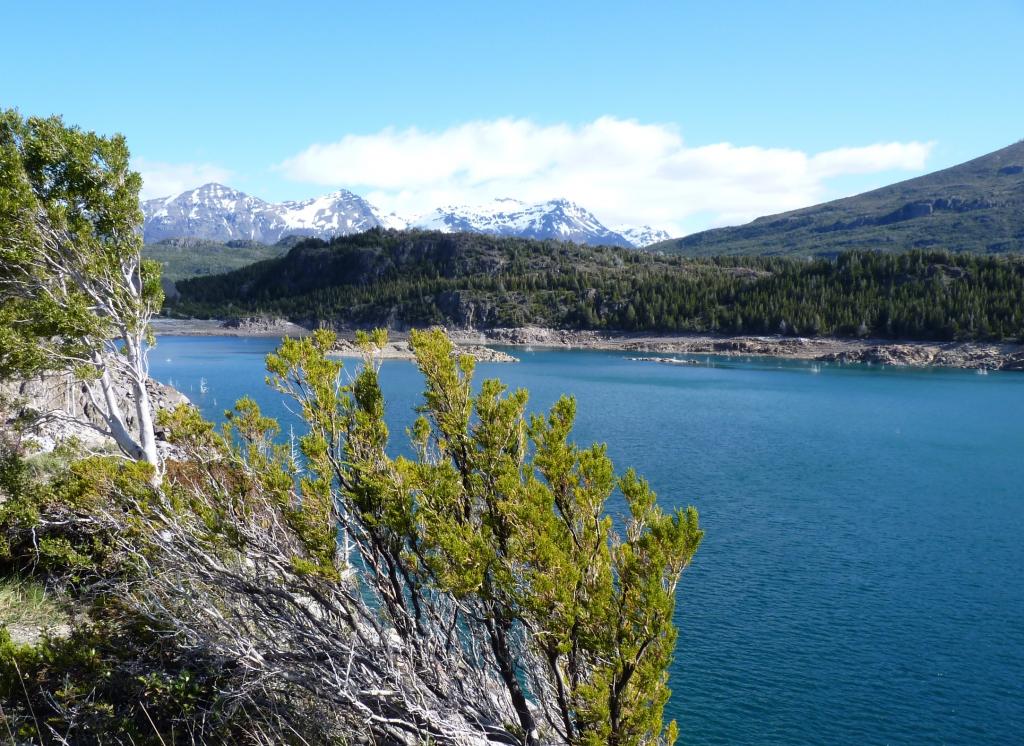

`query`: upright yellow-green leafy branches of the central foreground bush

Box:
[267,331,702,744]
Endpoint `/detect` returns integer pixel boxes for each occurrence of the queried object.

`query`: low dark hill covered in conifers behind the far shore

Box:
[166,230,1024,340]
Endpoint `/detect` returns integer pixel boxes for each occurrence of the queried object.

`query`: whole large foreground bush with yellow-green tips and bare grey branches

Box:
[0,332,701,744]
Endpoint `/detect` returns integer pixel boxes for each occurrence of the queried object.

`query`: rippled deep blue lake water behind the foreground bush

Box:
[151,338,1024,744]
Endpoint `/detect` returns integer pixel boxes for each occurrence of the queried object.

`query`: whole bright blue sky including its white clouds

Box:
[0,0,1024,232]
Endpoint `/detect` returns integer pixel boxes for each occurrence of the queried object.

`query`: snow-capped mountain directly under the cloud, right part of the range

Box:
[410,199,633,247]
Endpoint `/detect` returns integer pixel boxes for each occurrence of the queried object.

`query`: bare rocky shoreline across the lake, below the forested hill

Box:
[154,319,1024,370]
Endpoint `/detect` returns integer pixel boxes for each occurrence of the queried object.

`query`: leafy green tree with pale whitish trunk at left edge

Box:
[0,109,163,466]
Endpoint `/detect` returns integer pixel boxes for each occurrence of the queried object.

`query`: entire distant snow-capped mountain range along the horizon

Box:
[142,183,669,249]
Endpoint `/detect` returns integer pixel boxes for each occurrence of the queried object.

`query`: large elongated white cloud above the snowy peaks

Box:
[275,117,932,235]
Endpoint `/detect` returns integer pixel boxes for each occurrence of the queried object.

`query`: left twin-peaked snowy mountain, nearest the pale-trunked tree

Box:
[142,184,383,244]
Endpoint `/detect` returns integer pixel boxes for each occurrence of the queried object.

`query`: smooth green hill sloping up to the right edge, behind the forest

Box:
[648,140,1024,256]
